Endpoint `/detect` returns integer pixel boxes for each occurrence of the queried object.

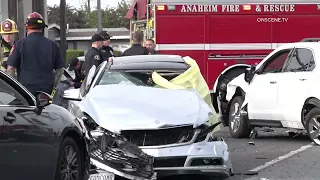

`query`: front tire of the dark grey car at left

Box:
[55,137,84,180]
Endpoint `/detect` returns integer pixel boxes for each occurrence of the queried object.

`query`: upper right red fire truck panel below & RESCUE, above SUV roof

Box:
[273,14,320,43]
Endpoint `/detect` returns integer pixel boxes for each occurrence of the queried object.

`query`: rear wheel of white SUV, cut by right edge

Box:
[306,107,320,146]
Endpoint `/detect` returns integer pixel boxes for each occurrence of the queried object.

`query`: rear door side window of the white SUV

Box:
[283,48,315,72]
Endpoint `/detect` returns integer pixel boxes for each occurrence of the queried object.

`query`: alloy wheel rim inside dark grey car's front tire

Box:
[60,145,80,180]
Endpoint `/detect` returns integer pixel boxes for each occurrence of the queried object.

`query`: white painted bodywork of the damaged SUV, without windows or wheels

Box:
[226,42,320,129]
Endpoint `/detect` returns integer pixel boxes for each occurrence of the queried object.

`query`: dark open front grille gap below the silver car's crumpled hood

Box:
[121,126,195,146]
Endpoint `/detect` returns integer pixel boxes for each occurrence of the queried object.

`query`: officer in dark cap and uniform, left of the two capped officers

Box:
[84,34,104,75]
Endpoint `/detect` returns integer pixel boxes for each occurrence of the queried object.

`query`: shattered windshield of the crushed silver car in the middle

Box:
[98,71,147,86]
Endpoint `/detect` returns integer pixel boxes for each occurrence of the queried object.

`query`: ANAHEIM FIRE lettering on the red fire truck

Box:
[181,5,240,12]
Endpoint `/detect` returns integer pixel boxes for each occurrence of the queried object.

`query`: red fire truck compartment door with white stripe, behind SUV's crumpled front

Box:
[207,14,272,88]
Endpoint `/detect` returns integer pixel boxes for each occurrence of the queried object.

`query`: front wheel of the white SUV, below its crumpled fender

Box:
[229,96,251,138]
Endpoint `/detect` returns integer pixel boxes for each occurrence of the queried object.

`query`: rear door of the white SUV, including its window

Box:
[278,47,316,129]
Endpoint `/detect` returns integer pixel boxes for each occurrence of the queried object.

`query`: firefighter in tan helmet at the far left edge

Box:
[0,19,19,71]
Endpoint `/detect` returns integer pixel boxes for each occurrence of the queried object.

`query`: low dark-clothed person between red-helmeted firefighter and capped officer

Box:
[68,57,85,89]
